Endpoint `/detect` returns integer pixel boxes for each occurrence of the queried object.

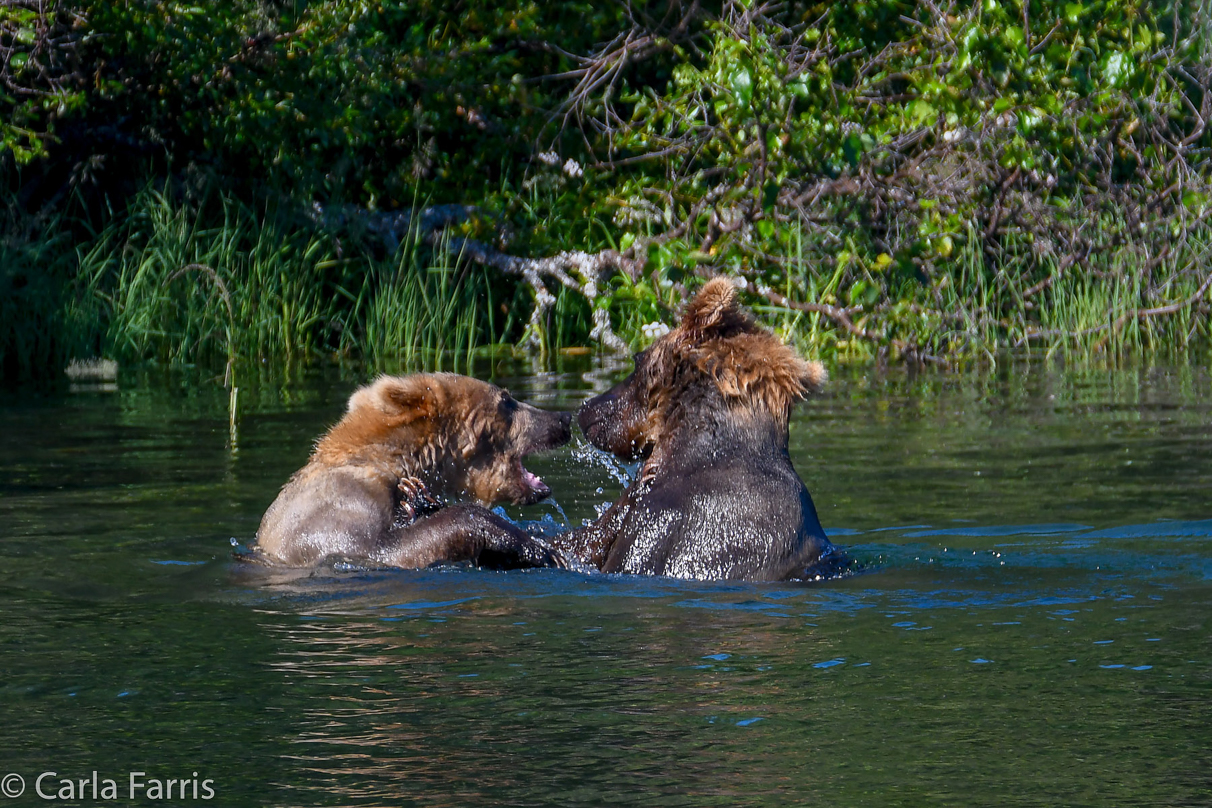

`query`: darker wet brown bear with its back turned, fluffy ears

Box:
[553,277,839,580]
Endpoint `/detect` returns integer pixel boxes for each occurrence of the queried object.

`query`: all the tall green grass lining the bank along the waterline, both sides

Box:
[0,189,1212,386]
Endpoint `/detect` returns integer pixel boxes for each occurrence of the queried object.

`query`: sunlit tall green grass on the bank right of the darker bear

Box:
[759,216,1212,362]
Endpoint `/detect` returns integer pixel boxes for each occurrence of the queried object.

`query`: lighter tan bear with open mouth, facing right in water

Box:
[255,373,572,568]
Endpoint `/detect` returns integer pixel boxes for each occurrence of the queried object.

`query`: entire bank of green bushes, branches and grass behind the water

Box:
[0,0,1212,377]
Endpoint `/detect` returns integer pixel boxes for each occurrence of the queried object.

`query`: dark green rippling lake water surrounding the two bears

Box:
[0,360,1212,807]
